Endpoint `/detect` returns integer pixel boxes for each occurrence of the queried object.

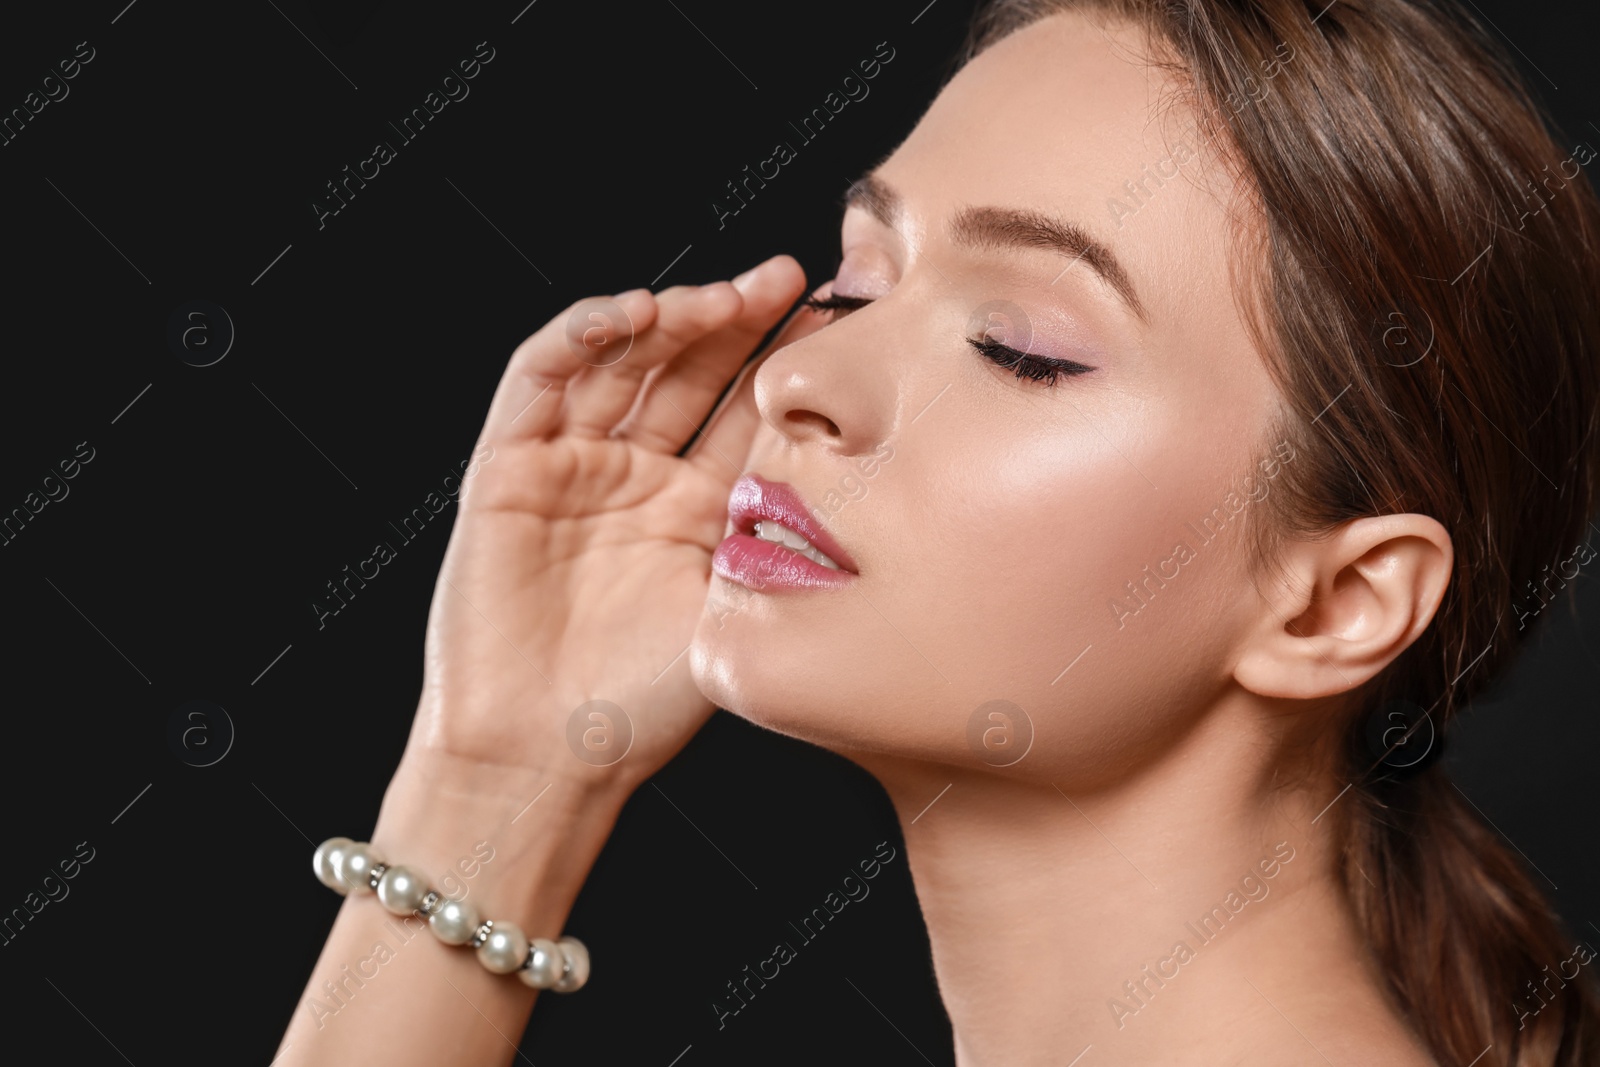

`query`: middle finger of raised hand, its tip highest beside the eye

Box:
[616,256,805,453]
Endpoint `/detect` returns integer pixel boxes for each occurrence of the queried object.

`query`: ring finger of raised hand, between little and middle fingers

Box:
[562,282,744,441]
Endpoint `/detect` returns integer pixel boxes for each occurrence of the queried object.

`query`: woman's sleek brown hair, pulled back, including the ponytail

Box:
[966,0,1600,1067]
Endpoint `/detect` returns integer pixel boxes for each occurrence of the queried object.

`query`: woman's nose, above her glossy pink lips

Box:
[755,312,899,456]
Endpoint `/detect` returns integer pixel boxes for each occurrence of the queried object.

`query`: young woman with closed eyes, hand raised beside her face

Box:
[285,0,1600,1067]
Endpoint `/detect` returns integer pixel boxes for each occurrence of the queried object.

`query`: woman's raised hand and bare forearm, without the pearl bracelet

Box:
[280,256,821,1067]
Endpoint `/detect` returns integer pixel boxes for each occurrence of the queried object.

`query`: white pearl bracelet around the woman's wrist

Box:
[310,837,589,993]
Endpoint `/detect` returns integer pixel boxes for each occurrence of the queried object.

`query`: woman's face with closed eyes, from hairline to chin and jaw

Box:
[691,16,1290,784]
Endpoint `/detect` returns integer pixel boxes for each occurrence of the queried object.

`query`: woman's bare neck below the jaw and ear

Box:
[859,700,1403,1067]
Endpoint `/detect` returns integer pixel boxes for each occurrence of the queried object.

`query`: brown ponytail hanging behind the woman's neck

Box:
[1336,757,1600,1067]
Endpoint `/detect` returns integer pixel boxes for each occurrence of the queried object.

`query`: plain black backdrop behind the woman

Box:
[0,0,1600,1067]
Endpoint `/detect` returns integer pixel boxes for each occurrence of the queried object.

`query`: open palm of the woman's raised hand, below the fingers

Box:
[432,438,738,777]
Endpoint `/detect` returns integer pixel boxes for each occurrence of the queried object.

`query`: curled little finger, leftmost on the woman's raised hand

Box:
[483,290,658,440]
